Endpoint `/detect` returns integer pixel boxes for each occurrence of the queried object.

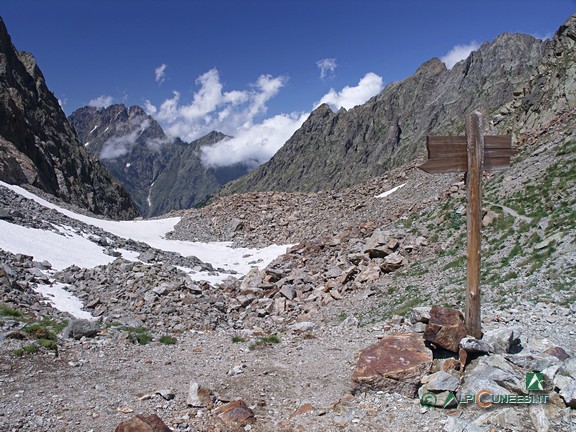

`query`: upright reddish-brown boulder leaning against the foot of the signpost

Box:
[424,306,466,352]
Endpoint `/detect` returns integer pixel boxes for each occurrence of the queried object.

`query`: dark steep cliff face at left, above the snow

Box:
[0,19,138,219]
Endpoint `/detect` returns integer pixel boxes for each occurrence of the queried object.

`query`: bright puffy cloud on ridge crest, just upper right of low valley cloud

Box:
[314,72,383,111]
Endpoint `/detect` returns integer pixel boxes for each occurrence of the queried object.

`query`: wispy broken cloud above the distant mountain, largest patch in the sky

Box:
[145,69,287,141]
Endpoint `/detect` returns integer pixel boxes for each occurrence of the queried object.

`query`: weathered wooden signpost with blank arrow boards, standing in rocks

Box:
[419,111,517,339]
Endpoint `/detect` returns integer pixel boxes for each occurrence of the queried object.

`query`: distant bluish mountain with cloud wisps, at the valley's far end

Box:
[70,105,248,216]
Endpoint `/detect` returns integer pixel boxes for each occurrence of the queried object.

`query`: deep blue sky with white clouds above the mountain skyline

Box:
[0,0,576,164]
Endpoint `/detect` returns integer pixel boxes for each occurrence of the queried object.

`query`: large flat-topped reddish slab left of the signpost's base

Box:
[352,333,432,397]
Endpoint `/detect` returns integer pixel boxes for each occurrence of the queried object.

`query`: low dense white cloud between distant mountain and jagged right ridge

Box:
[202,113,309,167]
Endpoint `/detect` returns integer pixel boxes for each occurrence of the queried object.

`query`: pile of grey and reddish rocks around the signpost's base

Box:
[352,306,576,431]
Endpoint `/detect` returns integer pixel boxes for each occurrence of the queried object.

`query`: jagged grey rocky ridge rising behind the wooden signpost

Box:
[222,34,547,194]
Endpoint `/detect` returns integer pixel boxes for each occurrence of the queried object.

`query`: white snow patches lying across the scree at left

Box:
[0,181,289,318]
